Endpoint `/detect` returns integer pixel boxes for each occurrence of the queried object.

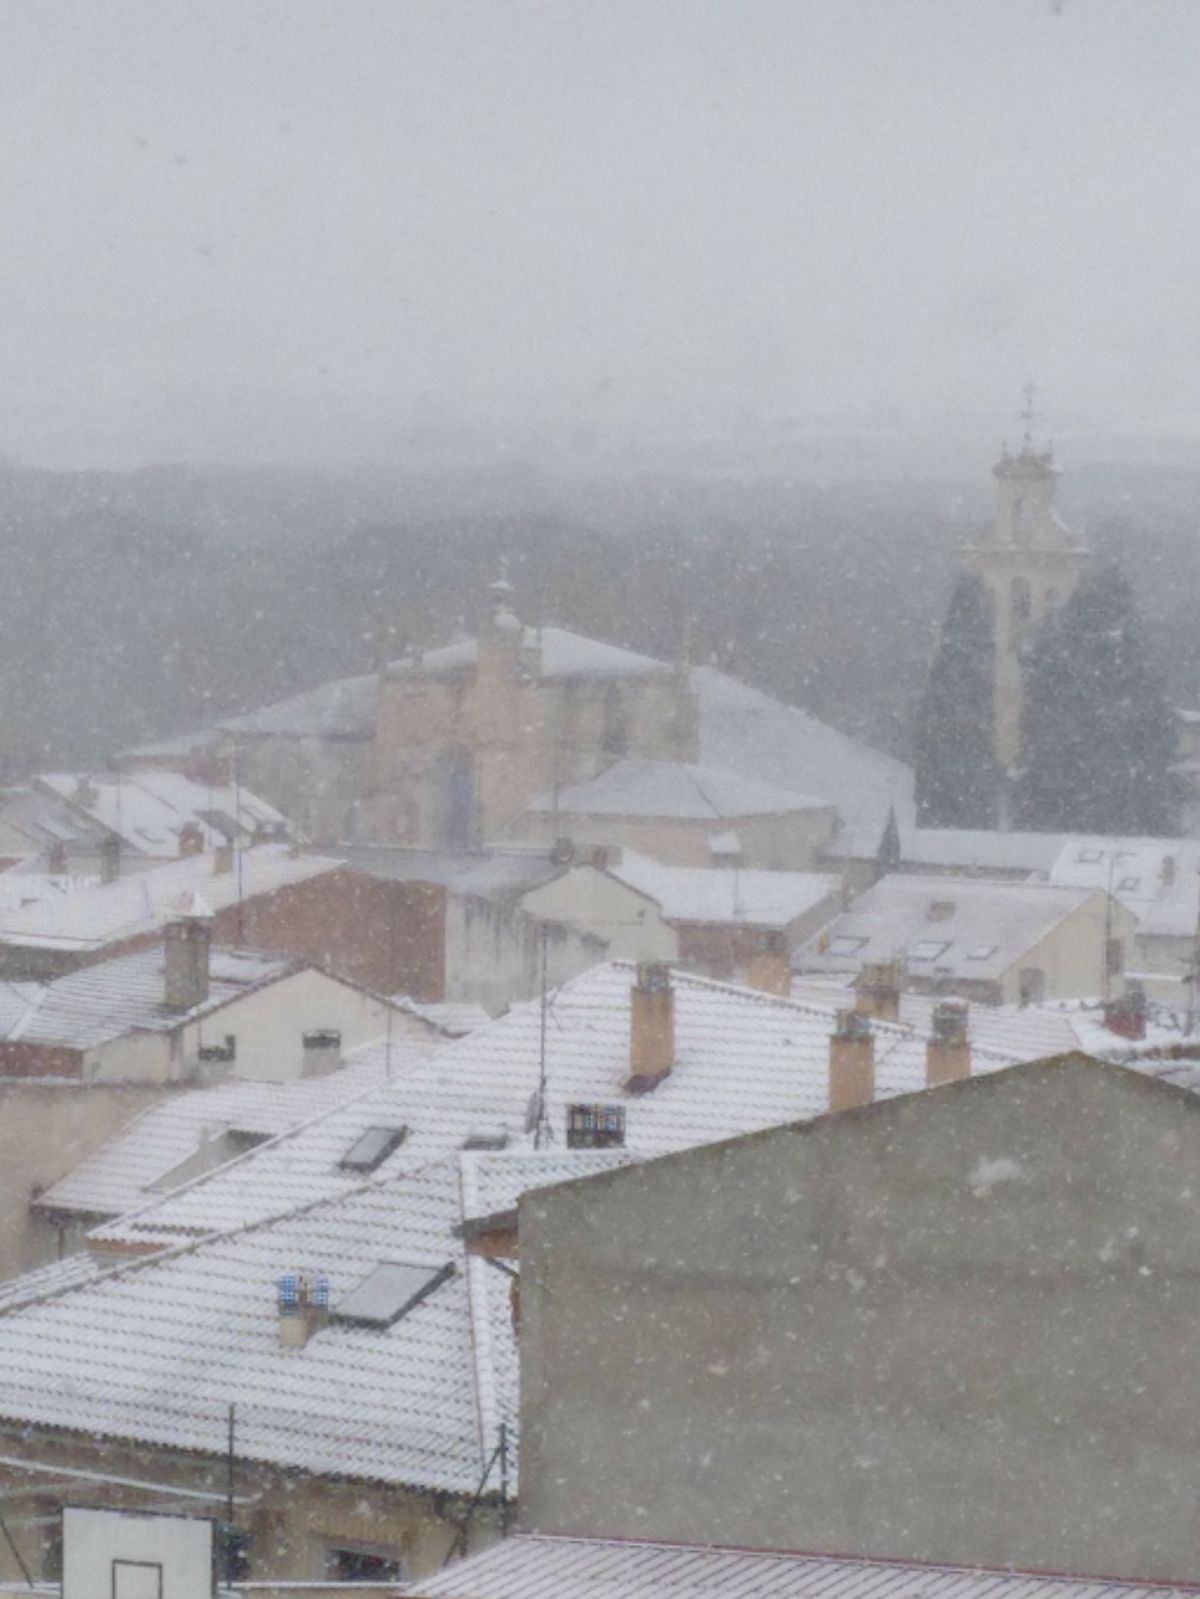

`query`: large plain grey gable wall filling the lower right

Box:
[520,1057,1200,1580]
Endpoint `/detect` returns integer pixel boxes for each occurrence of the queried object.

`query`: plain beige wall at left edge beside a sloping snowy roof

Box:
[0,1081,171,1278]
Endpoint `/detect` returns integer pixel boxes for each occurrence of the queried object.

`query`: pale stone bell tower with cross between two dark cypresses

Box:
[966,384,1088,774]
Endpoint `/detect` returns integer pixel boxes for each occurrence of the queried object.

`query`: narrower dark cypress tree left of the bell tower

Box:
[915,574,1000,827]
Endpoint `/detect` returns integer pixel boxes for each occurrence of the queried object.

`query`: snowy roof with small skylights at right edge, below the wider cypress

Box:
[1049,835,1200,939]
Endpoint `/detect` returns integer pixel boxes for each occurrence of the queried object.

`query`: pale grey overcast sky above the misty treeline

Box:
[0,0,1200,464]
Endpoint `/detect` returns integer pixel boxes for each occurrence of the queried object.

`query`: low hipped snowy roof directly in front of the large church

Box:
[530,761,829,822]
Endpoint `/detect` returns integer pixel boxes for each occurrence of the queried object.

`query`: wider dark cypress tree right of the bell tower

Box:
[1016,566,1179,836]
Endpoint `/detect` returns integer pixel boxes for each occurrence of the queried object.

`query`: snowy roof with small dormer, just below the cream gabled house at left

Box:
[38,1036,432,1217]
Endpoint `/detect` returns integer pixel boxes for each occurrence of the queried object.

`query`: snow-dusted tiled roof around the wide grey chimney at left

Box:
[0,948,304,1049]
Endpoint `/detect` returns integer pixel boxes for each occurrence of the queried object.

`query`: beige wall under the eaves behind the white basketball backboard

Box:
[0,1428,498,1599]
